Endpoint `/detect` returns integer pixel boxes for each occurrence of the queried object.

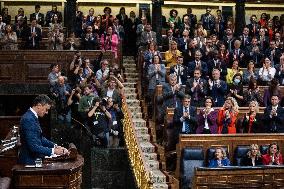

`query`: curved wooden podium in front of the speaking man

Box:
[12,154,84,189]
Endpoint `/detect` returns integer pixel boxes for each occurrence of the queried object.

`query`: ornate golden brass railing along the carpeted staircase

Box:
[122,97,153,189]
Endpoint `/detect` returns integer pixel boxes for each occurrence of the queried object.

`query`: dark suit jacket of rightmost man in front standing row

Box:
[263,105,284,133]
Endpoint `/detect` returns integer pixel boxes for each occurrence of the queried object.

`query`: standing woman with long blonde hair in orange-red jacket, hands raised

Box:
[217,97,239,134]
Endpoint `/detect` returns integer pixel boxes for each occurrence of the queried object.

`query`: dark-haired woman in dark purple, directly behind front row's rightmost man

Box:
[263,78,282,107]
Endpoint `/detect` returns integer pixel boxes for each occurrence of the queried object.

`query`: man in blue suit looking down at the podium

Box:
[18,95,69,165]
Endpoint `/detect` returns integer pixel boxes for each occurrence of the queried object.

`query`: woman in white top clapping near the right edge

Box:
[258,57,276,85]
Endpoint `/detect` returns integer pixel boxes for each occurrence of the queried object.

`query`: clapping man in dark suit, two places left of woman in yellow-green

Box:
[187,50,208,78]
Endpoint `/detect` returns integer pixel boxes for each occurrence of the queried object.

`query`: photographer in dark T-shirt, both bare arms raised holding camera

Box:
[88,98,112,147]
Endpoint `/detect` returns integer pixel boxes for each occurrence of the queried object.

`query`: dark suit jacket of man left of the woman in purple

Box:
[173,106,197,134]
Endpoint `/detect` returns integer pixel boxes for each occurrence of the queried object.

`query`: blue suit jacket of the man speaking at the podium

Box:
[19,110,54,165]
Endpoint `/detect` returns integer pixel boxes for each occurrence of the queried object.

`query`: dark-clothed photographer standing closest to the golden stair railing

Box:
[106,98,124,148]
